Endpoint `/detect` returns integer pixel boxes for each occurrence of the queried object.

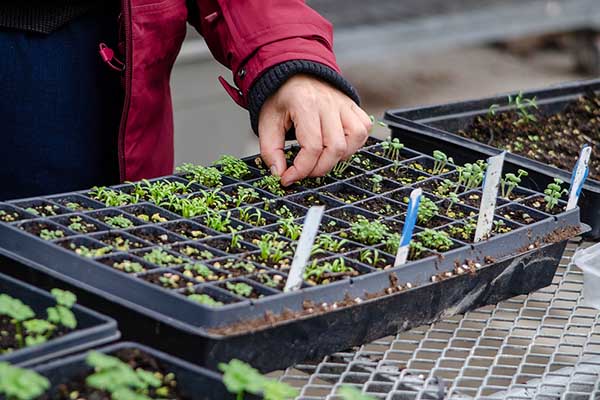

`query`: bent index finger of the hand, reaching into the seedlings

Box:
[281,111,323,186]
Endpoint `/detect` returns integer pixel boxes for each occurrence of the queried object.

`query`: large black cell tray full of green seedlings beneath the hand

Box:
[0,139,586,370]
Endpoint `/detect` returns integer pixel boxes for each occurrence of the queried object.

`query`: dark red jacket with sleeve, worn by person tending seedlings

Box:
[119,0,339,181]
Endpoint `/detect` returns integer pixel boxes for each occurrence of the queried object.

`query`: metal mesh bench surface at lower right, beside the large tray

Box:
[280,241,600,400]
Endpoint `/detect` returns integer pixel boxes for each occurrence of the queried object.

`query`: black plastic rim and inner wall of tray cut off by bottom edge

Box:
[34,342,234,400]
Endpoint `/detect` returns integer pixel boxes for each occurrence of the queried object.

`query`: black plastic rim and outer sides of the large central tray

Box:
[0,139,585,370]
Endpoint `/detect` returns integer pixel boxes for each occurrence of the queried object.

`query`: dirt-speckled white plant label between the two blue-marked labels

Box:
[475,151,506,242]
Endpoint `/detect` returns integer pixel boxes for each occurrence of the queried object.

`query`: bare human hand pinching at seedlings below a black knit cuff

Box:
[258,75,372,186]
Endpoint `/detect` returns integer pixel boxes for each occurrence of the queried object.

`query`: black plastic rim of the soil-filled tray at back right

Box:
[384,79,600,240]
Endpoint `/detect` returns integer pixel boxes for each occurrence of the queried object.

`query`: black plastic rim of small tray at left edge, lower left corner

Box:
[0,274,120,366]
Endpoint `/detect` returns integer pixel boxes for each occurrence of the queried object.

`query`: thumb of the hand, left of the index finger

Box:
[258,104,287,176]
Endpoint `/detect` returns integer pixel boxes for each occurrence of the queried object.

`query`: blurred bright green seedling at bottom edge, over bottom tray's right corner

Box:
[219,359,298,400]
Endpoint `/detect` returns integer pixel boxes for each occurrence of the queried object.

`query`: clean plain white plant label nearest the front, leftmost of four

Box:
[283,206,325,292]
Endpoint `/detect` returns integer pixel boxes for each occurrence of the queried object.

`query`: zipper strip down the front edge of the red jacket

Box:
[117,0,133,182]
